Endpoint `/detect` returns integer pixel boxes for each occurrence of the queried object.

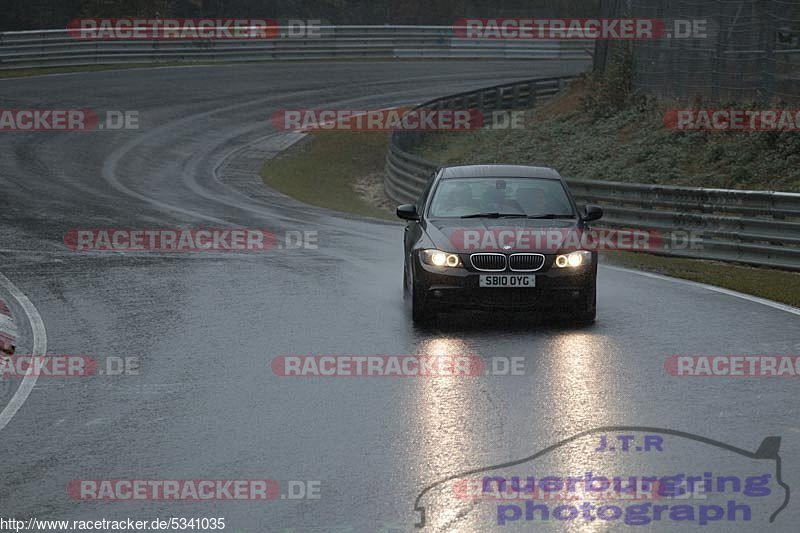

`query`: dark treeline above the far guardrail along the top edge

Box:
[0,0,599,31]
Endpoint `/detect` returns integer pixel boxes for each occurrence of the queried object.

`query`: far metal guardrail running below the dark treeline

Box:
[0,26,594,69]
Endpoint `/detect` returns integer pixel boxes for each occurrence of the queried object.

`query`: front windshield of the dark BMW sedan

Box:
[429,178,575,218]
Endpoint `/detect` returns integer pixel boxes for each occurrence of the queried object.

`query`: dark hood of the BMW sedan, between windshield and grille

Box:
[426,218,579,253]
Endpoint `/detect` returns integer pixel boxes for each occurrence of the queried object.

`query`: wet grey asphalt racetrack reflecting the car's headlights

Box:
[0,62,800,532]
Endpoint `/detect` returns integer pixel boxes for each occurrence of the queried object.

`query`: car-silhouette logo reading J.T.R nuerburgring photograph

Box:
[414,426,790,531]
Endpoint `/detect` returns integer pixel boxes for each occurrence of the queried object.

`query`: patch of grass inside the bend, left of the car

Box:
[261,131,397,220]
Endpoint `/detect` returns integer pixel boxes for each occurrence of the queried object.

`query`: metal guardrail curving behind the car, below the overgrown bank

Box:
[384,78,800,271]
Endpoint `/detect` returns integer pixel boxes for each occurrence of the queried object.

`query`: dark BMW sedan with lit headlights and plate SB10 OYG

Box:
[397,165,603,324]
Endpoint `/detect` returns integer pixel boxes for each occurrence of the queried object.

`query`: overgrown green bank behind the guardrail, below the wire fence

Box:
[417,75,800,192]
